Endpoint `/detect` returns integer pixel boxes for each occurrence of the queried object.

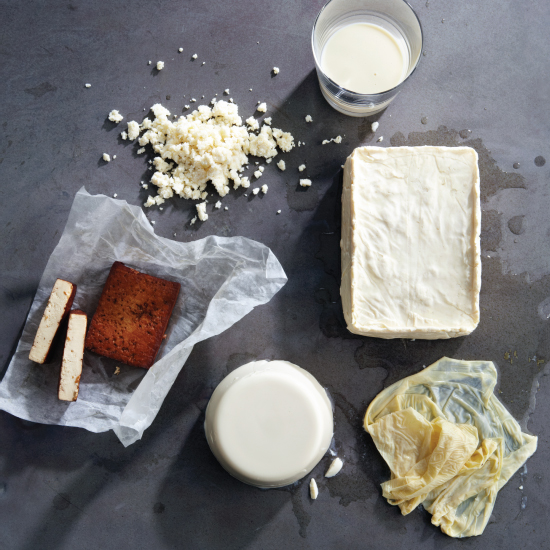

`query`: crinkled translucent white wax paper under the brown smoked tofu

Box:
[0,188,287,446]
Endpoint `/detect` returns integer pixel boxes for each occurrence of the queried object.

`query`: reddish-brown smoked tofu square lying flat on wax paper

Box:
[86,262,180,369]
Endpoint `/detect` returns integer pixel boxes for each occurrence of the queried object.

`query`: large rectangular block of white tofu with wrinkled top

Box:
[340,147,481,339]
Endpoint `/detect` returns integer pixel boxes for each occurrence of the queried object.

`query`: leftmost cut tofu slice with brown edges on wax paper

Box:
[29,279,76,364]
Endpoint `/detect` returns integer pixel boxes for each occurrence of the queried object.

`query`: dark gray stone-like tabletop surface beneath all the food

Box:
[0,0,550,550]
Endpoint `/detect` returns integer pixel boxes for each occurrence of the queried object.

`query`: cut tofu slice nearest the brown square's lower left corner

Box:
[57,309,88,401]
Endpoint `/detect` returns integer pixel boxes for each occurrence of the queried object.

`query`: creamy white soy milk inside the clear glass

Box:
[321,23,408,94]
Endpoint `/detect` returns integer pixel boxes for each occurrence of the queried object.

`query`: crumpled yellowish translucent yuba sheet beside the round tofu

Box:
[364,357,537,537]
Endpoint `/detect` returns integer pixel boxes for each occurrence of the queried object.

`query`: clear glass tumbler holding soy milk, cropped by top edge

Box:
[311,0,422,117]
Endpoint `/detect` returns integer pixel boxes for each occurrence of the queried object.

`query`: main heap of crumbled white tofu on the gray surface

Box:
[121,101,294,206]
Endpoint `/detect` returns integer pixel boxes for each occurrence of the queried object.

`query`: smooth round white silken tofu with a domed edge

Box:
[204,361,333,487]
